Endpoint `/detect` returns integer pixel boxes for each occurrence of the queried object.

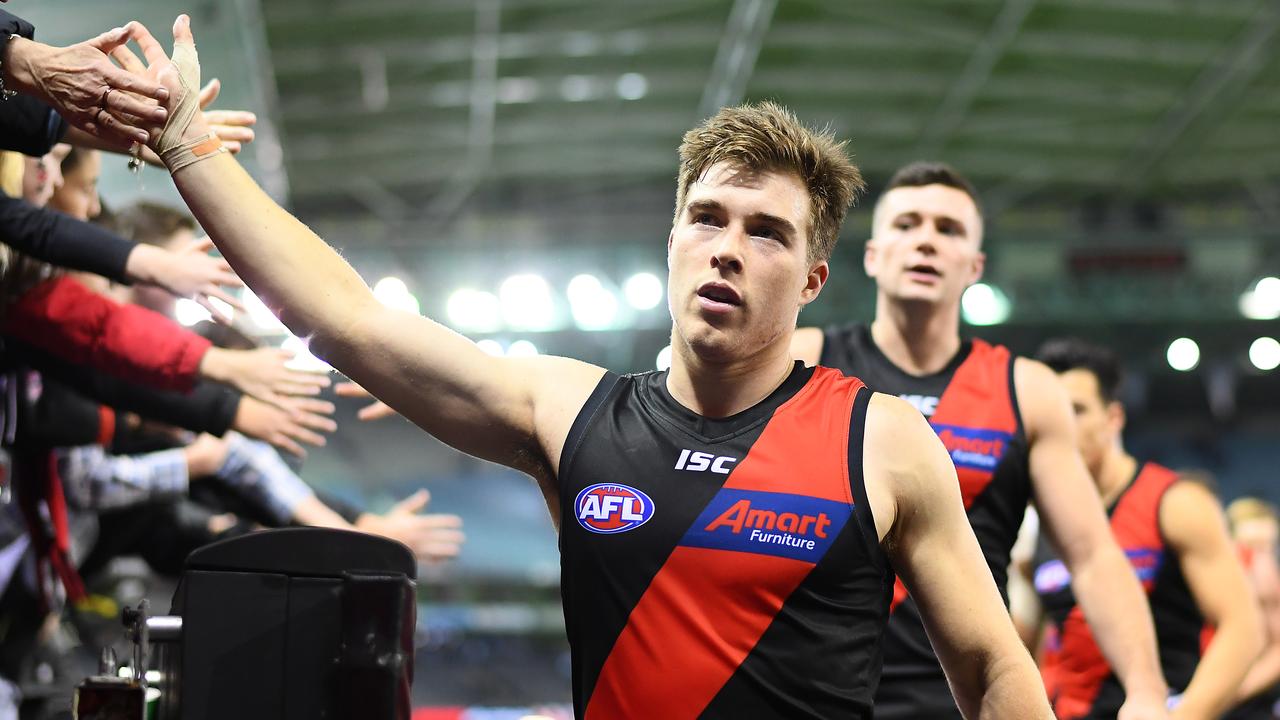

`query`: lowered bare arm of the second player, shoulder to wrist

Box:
[1014,357,1167,720]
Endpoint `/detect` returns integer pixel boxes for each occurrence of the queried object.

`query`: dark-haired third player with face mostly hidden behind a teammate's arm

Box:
[1033,340,1263,720]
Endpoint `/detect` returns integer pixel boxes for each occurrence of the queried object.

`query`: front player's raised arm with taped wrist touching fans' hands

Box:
[132,17,603,479]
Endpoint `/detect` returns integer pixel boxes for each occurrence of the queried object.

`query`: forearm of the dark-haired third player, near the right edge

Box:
[1179,607,1262,719]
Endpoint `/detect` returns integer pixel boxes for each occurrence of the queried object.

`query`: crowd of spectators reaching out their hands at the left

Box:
[0,12,462,720]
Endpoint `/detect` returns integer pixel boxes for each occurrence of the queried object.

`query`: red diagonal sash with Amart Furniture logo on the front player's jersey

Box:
[586,368,861,720]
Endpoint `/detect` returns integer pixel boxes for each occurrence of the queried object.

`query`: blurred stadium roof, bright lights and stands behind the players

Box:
[20,0,1280,716]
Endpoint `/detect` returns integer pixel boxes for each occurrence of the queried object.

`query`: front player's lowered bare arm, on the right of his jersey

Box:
[864,395,1052,719]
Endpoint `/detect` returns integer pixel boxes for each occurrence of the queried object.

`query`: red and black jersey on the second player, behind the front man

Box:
[820,324,1030,720]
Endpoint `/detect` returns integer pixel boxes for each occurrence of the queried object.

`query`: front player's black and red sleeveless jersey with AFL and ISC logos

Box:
[559,363,892,720]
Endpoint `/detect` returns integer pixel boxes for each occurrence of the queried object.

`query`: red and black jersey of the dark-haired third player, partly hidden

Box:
[1034,462,1204,720]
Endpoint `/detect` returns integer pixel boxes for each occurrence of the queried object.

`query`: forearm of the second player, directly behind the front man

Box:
[1070,543,1167,697]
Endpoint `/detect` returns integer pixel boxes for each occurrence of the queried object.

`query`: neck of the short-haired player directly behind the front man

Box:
[872,297,960,375]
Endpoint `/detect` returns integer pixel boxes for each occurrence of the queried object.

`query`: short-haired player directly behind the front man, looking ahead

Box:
[791,163,1166,720]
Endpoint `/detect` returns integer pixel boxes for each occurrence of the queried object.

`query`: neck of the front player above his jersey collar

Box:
[667,338,794,418]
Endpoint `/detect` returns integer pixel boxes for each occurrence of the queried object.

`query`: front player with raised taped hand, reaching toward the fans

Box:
[118,18,1050,719]
